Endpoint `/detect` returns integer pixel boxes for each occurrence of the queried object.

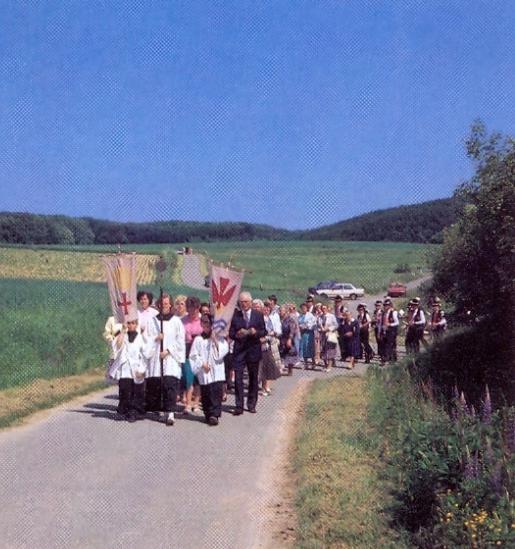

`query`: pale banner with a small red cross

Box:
[102,253,138,322]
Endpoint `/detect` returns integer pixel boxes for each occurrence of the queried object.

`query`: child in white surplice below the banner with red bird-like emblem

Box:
[190,315,229,425]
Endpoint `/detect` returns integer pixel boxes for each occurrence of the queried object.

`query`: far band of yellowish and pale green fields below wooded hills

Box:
[0,241,437,299]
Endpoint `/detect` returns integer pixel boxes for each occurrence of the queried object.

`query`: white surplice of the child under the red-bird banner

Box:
[190,336,229,385]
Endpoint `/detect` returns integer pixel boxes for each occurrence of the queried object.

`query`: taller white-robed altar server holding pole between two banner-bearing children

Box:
[146,294,186,425]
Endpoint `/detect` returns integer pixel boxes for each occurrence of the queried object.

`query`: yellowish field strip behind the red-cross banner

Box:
[0,248,158,284]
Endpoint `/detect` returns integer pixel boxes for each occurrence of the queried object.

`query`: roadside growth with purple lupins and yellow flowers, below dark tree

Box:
[368,363,515,548]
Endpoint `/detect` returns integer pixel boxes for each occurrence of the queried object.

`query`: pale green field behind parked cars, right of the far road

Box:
[189,241,435,297]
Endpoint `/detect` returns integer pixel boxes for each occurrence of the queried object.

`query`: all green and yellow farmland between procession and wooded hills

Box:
[0,241,431,389]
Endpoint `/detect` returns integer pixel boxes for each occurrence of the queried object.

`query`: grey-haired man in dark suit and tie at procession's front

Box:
[229,292,266,416]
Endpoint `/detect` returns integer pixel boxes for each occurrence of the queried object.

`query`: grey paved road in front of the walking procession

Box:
[0,365,364,549]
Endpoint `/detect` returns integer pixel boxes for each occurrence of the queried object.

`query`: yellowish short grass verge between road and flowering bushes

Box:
[293,376,405,548]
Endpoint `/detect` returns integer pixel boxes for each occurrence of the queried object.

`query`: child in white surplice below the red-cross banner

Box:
[111,320,154,423]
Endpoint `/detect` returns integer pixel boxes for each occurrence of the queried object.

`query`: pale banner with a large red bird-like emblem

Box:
[209,263,243,336]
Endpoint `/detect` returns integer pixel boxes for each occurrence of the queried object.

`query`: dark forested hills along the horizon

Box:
[0,198,459,245]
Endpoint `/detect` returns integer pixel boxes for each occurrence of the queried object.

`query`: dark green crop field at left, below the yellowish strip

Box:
[0,279,207,389]
